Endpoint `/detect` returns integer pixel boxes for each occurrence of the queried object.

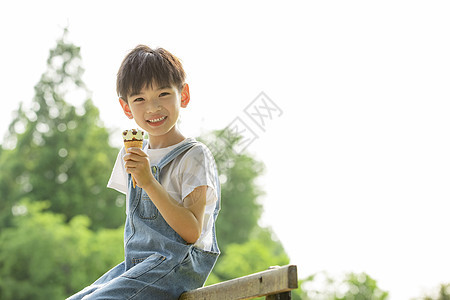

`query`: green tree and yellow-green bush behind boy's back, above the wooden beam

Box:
[199,129,289,285]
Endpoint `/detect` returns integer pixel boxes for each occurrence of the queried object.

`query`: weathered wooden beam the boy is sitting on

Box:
[179,265,298,300]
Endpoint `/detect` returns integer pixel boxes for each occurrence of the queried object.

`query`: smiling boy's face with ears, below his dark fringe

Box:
[120,84,190,137]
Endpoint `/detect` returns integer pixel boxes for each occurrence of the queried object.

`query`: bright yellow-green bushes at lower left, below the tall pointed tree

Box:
[0,201,123,299]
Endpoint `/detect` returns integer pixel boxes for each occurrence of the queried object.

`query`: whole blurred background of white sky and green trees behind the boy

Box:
[0,0,450,299]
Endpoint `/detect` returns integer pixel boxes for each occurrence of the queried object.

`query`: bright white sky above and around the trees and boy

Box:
[0,0,450,299]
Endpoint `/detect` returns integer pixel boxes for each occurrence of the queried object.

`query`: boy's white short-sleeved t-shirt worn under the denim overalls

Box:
[107,138,217,251]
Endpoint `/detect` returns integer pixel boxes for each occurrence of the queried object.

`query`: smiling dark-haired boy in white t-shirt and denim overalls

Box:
[69,45,220,300]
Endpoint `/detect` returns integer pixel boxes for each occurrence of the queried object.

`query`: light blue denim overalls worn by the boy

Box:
[69,140,220,300]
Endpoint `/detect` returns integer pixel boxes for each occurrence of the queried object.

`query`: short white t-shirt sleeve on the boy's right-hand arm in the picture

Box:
[180,143,217,205]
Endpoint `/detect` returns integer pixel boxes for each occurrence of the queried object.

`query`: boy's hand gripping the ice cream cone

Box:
[123,148,153,188]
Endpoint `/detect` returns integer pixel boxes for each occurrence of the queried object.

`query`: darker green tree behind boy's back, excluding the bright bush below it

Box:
[199,130,264,251]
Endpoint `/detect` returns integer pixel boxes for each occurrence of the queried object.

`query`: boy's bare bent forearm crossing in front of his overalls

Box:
[143,179,202,244]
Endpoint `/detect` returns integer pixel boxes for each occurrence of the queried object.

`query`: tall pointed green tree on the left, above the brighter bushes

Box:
[0,30,124,228]
